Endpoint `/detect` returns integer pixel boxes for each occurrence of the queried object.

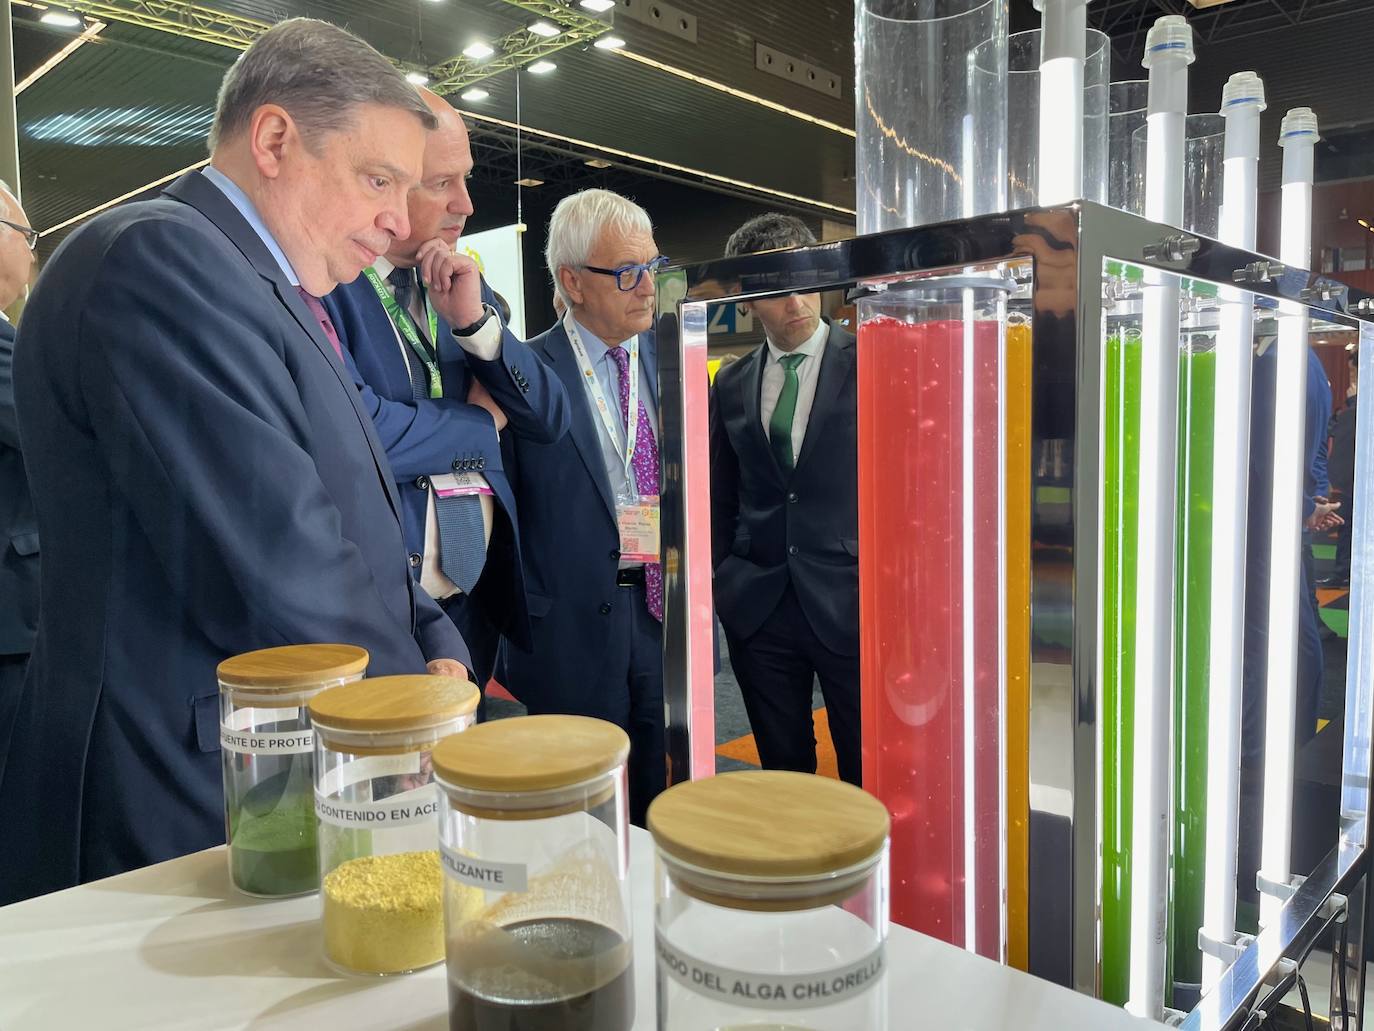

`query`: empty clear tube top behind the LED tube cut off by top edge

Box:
[976,29,1112,208]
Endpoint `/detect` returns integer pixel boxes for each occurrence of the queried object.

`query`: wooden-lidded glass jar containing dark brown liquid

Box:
[434,716,635,1031]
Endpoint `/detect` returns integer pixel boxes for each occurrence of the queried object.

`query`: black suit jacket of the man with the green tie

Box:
[710,326,859,656]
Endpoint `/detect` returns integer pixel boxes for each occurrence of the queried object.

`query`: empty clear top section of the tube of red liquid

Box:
[855,0,1007,234]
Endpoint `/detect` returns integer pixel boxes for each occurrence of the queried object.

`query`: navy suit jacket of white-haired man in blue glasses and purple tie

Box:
[503,322,661,715]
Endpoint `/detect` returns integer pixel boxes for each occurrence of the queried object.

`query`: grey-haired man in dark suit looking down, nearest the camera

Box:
[0,19,469,903]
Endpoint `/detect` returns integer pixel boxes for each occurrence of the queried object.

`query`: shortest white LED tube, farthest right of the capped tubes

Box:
[1260,107,1316,927]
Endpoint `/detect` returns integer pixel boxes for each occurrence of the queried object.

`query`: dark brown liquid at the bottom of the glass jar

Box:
[448,918,635,1031]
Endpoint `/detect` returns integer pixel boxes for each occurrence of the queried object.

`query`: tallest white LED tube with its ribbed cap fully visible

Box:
[1127,15,1193,1020]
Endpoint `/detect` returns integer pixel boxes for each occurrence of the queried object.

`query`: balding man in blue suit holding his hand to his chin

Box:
[326,91,569,703]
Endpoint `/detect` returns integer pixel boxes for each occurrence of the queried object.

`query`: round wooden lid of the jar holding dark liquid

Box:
[433,716,629,795]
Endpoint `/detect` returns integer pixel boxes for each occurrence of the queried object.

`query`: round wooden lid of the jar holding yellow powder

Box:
[311,674,482,733]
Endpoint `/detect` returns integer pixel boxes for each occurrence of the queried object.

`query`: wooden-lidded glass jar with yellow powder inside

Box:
[311,675,480,975]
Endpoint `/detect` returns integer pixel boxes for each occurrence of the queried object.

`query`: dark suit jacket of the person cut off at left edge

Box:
[0,320,38,657]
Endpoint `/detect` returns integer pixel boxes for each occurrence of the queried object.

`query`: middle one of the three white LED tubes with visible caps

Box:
[1202,71,1264,991]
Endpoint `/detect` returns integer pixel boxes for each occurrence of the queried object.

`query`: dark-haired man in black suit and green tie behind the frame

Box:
[710,213,860,784]
